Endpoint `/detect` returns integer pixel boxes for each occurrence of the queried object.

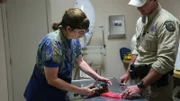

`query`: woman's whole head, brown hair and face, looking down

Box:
[53,8,90,39]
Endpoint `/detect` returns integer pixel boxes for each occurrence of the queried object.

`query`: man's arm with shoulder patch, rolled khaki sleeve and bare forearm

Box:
[142,21,180,86]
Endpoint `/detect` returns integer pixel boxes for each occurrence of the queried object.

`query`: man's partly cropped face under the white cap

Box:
[137,0,155,15]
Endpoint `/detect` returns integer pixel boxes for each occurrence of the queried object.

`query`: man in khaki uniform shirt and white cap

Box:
[120,0,180,101]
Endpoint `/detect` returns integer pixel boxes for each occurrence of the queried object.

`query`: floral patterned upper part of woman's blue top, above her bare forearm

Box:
[36,30,81,78]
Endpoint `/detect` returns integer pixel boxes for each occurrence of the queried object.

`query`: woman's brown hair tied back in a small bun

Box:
[52,8,90,30]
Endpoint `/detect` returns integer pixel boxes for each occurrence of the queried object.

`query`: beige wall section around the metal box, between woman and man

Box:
[90,0,139,78]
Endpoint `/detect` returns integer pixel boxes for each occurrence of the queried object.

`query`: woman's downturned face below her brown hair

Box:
[67,26,88,39]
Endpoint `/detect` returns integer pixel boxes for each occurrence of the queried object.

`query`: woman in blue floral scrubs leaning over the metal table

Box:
[24,8,111,101]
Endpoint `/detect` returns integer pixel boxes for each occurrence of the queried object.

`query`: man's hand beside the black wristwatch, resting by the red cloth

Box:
[121,85,143,98]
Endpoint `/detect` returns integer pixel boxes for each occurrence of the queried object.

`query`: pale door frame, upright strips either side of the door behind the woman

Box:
[1,0,51,101]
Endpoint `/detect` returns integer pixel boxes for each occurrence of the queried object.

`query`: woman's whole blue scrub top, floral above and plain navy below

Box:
[24,30,81,101]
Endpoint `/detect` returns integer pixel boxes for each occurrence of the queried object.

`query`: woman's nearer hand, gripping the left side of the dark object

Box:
[79,84,98,96]
